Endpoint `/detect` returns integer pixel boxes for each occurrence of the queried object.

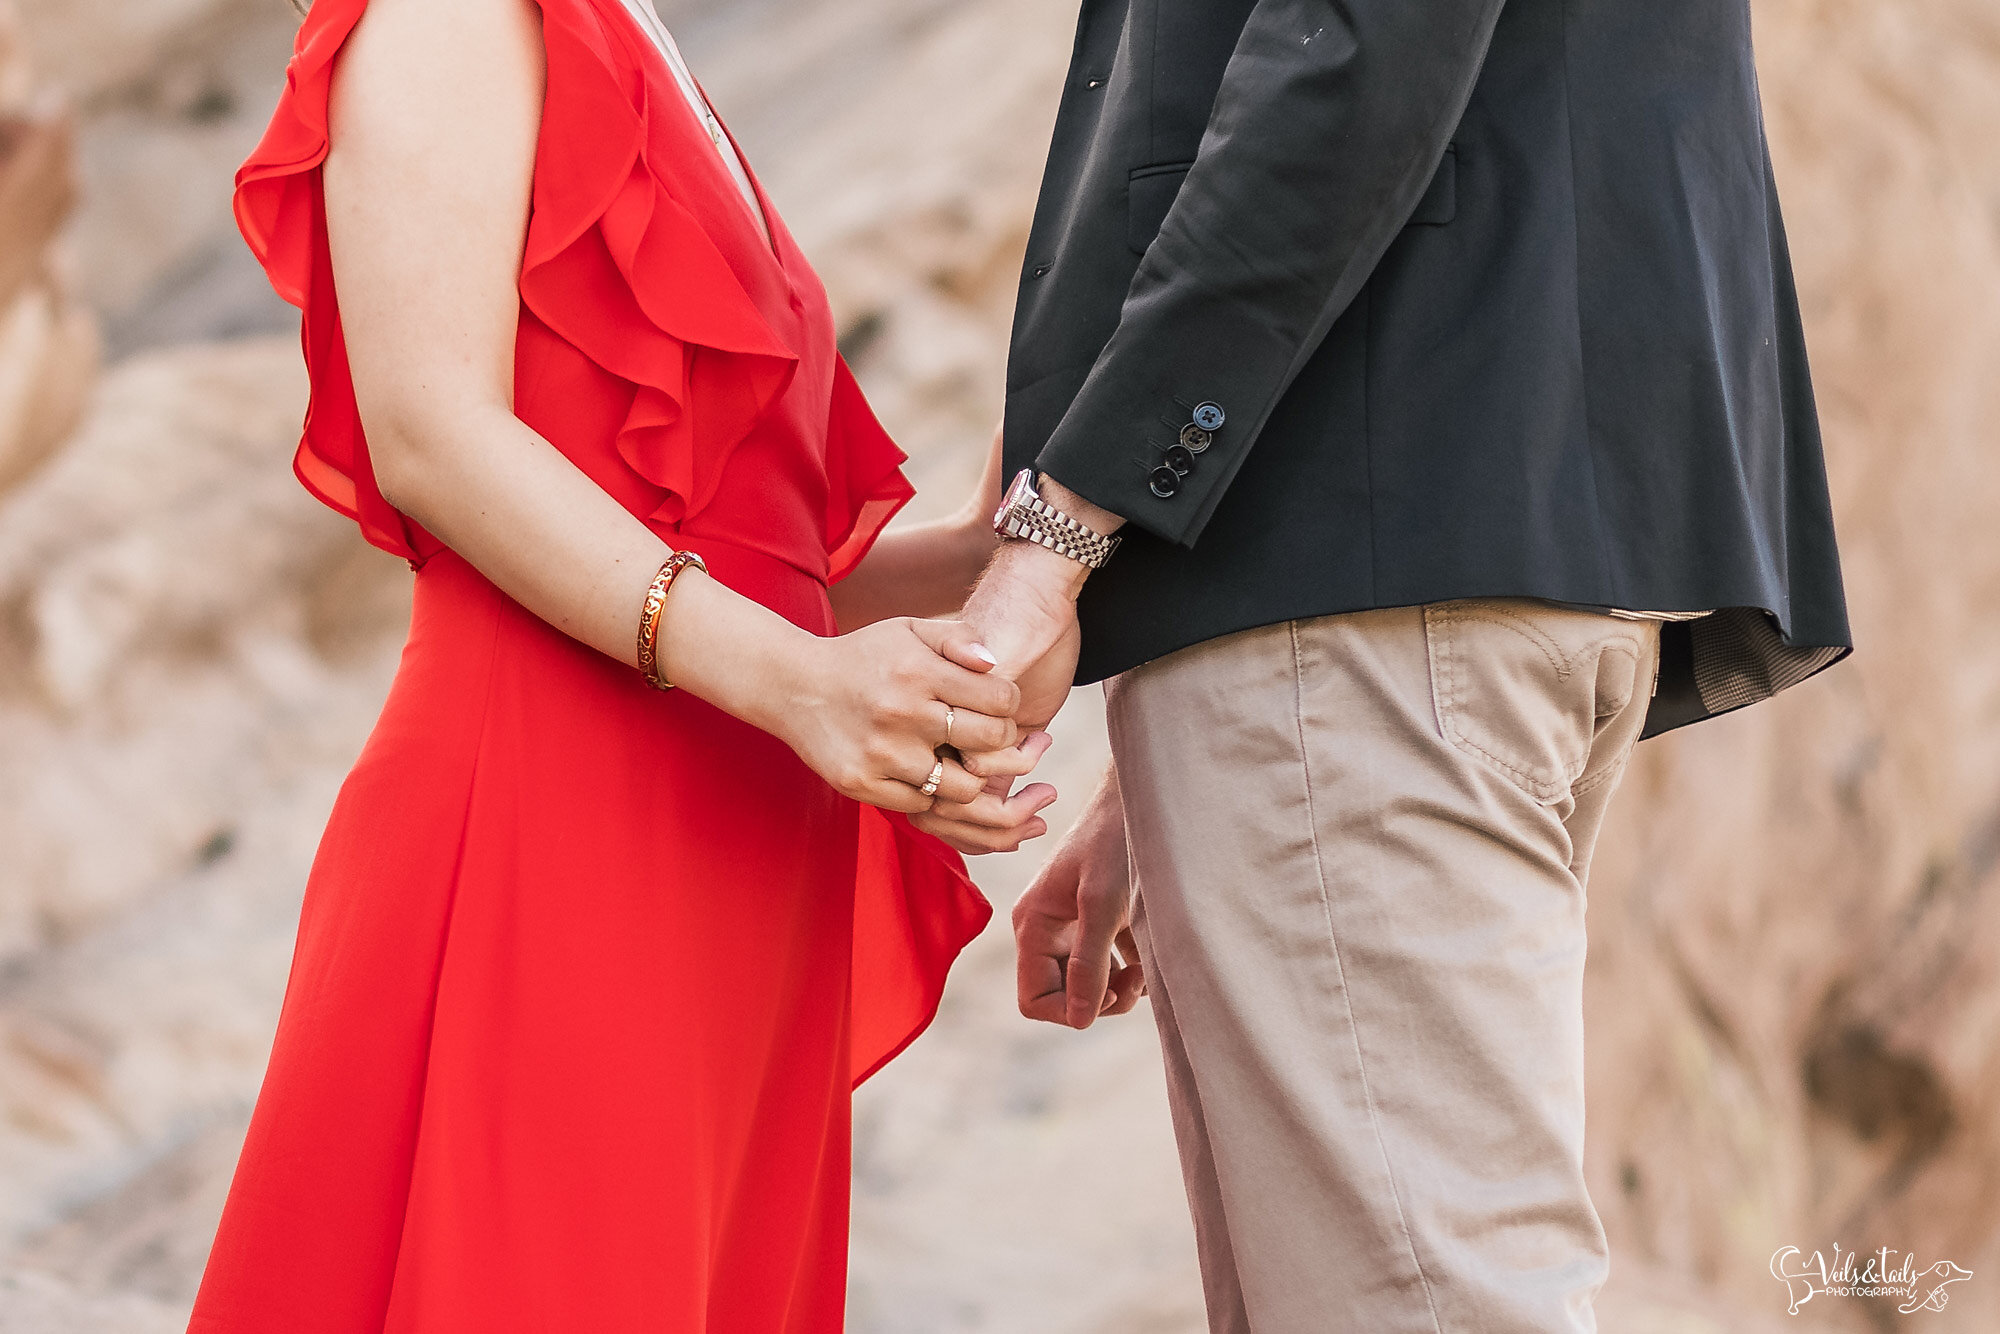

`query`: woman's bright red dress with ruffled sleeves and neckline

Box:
[190,0,990,1334]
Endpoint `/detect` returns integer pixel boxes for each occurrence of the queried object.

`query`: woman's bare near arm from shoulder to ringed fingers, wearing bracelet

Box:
[324,0,1018,822]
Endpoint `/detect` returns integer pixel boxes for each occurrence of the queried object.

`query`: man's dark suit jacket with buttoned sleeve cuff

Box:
[1006,0,1850,734]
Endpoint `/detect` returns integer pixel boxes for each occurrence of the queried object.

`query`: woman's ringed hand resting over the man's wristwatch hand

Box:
[766,618,1020,812]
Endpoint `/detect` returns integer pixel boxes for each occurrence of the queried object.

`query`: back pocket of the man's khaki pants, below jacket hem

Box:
[1424,598,1648,806]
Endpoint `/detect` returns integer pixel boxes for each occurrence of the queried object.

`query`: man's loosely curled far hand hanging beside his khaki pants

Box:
[1014,770,1146,1028]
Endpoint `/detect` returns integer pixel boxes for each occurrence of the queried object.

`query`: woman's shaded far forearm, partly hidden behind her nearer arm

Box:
[834,430,1000,630]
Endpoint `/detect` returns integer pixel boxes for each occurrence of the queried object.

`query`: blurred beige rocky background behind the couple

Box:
[0,0,2000,1334]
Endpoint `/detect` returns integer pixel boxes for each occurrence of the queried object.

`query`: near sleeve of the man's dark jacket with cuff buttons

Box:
[1036,0,1502,546]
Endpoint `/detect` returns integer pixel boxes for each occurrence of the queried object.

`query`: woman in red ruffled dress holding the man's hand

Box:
[190,0,1052,1334]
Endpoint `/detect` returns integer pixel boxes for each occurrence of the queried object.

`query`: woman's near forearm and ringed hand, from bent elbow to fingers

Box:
[370,398,1020,828]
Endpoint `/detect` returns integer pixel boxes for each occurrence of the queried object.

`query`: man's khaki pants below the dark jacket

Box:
[1108,600,1660,1334]
